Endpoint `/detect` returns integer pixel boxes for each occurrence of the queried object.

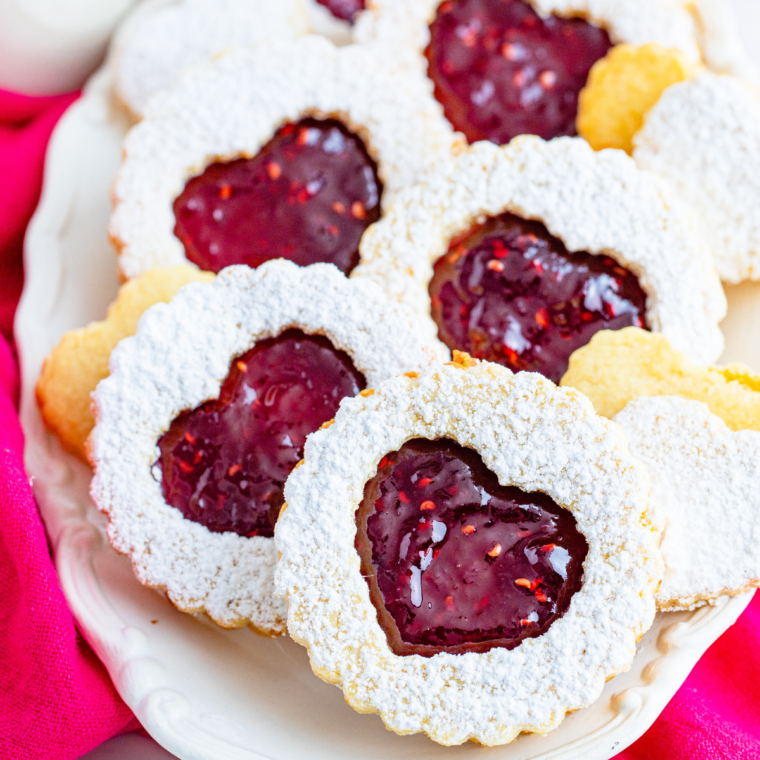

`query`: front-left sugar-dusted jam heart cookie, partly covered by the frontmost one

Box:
[90,261,447,635]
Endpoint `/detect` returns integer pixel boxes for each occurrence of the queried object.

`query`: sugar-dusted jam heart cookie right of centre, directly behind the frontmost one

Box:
[352,137,726,382]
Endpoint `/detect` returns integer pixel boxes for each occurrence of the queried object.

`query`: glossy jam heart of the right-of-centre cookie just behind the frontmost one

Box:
[429,213,646,383]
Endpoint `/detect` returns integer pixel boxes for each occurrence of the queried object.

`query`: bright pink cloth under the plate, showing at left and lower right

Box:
[0,84,760,760]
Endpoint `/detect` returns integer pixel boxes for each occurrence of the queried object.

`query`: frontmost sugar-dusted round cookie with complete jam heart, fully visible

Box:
[275,354,661,746]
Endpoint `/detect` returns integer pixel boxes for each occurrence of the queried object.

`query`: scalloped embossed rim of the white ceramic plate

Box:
[15,0,753,760]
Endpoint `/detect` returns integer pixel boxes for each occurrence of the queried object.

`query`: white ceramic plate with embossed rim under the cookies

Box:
[16,4,760,760]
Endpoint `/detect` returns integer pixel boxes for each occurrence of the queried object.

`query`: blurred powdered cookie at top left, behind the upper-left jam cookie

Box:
[114,0,309,117]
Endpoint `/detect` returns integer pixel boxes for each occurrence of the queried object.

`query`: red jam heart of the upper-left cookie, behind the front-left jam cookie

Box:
[174,118,382,274]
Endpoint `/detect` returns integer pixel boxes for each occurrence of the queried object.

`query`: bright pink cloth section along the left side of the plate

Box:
[0,91,133,760]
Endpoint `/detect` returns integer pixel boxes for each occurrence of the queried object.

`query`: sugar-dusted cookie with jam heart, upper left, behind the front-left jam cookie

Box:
[110,37,458,278]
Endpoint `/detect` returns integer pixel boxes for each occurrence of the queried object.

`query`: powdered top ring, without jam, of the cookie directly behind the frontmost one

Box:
[351,137,726,364]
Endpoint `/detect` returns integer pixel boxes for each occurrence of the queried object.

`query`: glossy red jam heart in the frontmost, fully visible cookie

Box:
[356,439,588,657]
